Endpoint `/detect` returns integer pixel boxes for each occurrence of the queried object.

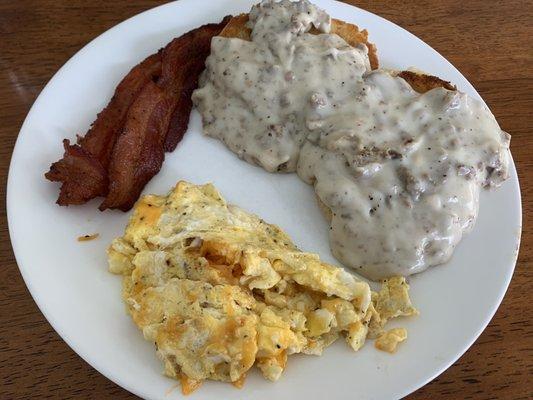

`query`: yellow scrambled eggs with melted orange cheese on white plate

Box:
[108,181,417,393]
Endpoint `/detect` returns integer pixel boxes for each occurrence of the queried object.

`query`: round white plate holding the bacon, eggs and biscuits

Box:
[7,0,521,400]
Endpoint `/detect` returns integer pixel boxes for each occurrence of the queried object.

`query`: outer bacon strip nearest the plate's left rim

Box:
[45,53,161,206]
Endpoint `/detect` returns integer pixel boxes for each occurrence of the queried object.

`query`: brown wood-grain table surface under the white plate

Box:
[0,0,533,400]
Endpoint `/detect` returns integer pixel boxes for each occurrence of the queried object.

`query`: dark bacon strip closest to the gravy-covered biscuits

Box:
[99,17,229,211]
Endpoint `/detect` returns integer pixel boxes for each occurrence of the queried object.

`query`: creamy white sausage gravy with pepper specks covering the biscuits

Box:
[193,0,509,279]
